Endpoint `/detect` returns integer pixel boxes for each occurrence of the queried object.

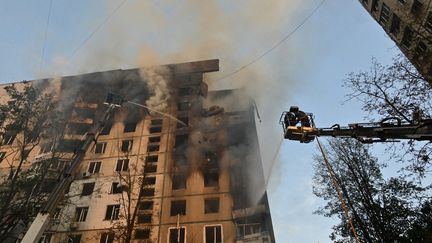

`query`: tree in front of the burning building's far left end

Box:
[0,83,66,242]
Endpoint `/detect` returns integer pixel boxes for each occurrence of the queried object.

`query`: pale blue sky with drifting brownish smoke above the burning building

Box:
[0,0,399,242]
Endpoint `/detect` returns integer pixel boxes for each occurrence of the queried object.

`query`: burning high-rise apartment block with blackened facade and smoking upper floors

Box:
[0,60,275,243]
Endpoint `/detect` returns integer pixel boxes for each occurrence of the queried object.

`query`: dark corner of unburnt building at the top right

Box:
[359,0,432,84]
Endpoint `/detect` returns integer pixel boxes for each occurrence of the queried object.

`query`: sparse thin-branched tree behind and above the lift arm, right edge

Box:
[344,54,432,178]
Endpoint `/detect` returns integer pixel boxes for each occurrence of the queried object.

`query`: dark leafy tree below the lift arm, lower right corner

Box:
[313,138,432,242]
